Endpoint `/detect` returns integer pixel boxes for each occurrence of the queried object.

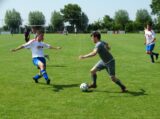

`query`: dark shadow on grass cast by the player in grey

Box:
[96,89,148,96]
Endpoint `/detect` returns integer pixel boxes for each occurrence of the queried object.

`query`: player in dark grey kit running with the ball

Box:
[79,31,127,92]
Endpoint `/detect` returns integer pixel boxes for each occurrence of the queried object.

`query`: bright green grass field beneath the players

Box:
[0,34,160,119]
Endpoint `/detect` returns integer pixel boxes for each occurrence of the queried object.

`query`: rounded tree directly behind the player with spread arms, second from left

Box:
[29,11,45,25]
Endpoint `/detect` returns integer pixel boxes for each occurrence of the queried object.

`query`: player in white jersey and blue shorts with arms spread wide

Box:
[11,33,60,84]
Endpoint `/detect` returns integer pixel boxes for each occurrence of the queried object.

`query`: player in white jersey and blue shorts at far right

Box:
[144,23,159,63]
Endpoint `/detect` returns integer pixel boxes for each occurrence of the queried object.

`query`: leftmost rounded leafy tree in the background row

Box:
[5,9,22,32]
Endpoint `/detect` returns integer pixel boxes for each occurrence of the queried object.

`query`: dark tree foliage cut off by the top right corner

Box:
[150,0,160,16]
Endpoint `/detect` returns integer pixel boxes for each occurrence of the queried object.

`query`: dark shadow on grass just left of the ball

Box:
[52,84,79,92]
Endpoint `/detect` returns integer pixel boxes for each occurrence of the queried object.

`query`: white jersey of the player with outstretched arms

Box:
[23,39,50,58]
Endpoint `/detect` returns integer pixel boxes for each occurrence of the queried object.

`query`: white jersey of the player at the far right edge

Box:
[145,29,155,45]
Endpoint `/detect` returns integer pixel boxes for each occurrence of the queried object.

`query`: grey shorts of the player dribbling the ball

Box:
[94,59,115,76]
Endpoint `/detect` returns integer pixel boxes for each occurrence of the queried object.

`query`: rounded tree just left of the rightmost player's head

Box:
[135,9,152,30]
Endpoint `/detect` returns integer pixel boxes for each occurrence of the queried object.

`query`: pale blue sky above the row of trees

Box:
[0,0,151,26]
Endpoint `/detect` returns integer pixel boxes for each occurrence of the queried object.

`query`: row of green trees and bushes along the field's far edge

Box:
[2,0,160,33]
